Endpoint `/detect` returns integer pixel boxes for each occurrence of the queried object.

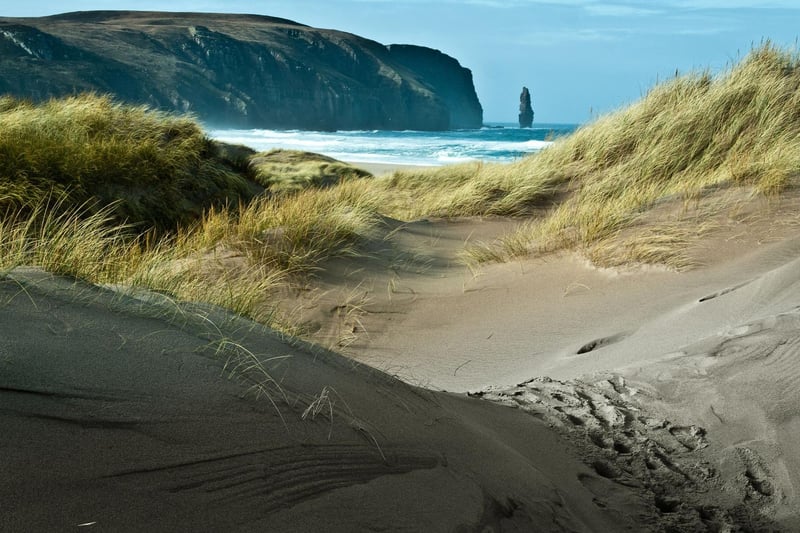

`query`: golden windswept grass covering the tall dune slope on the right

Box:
[384,43,800,266]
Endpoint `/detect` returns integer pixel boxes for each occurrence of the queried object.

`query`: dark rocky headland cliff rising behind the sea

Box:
[0,11,483,130]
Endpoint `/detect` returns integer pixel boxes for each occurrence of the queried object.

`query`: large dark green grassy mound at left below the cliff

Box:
[0,95,260,229]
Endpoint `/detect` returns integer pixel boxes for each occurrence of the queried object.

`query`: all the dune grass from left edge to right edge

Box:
[0,44,800,324]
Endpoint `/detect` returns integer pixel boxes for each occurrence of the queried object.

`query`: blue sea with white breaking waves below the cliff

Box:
[208,123,578,166]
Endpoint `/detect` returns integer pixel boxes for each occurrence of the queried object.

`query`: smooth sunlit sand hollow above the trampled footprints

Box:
[328,216,800,392]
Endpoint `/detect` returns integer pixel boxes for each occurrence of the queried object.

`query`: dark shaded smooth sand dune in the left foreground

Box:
[0,271,659,531]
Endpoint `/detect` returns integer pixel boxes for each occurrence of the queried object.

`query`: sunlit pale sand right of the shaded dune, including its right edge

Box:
[302,210,800,530]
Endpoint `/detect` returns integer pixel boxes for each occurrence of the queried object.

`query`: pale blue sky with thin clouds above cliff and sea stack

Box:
[0,0,800,123]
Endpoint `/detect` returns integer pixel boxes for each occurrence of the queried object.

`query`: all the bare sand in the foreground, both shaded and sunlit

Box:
[0,190,800,531]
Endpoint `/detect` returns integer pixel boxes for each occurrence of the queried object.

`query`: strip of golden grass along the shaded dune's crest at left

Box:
[0,197,287,328]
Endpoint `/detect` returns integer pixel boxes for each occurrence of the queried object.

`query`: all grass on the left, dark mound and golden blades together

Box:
[0,95,378,330]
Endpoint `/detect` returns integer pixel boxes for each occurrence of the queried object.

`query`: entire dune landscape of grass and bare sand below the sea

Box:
[7,42,800,532]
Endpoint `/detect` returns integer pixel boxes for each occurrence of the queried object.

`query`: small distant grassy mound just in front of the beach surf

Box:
[250,149,372,194]
